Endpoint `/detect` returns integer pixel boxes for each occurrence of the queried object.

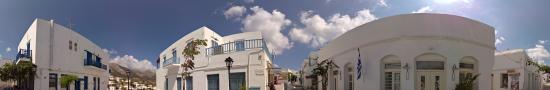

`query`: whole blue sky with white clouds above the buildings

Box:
[0,0,550,69]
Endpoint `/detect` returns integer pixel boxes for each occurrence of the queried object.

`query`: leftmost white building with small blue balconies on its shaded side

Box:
[16,19,109,90]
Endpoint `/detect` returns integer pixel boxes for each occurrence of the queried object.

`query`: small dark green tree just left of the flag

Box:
[312,60,338,90]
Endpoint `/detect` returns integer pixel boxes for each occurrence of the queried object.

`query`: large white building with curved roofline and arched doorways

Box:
[319,13,495,90]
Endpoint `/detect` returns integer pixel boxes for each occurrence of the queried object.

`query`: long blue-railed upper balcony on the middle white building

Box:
[206,39,269,55]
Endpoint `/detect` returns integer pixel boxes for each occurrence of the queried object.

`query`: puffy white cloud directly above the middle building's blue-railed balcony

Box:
[242,6,292,54]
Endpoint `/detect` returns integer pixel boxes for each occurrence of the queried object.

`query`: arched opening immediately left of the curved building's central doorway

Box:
[381,55,401,90]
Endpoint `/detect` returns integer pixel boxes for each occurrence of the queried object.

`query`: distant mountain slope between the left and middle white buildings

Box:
[109,63,155,85]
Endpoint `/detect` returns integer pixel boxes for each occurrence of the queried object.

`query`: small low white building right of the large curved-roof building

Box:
[493,49,544,90]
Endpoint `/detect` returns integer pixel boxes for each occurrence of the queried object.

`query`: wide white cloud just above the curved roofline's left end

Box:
[289,9,376,47]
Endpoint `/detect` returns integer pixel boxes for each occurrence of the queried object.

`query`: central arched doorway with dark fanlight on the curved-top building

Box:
[415,53,447,90]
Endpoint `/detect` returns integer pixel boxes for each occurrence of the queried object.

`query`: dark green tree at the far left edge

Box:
[0,61,36,89]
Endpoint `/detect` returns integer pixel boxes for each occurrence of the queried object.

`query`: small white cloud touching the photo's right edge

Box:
[527,40,550,64]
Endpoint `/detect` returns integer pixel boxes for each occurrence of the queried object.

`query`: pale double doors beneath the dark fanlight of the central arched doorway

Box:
[416,71,446,90]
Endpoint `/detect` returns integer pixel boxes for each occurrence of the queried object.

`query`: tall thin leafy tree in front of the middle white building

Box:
[181,39,207,78]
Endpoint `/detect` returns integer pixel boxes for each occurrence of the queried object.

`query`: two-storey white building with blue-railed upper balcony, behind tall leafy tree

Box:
[156,27,271,90]
